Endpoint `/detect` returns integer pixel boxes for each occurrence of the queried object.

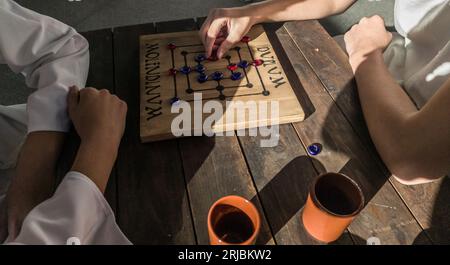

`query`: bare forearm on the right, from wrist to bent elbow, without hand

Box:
[355,51,429,179]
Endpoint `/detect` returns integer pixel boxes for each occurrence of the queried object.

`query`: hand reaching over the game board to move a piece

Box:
[199,8,256,59]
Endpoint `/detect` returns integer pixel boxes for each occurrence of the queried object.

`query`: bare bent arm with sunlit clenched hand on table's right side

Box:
[344,16,450,184]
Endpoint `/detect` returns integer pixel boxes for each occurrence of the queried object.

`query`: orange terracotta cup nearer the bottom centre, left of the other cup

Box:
[208,196,261,245]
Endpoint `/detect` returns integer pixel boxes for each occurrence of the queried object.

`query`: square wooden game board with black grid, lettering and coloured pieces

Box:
[140,26,304,142]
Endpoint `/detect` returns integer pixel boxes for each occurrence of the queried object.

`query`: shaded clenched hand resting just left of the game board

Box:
[67,87,127,146]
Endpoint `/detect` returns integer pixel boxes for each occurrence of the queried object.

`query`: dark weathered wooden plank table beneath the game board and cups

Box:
[59,18,450,244]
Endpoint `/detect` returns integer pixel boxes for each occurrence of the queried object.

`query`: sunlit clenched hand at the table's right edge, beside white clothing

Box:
[344,16,392,72]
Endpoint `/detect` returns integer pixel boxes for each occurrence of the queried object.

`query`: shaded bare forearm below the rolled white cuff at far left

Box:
[8,132,64,237]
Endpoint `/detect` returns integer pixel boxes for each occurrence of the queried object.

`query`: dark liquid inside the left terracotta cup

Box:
[213,205,255,244]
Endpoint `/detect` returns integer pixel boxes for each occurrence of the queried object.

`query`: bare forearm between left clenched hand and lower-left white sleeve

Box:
[72,137,118,193]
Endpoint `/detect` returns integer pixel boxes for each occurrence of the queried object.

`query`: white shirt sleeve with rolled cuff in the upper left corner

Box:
[0,0,89,132]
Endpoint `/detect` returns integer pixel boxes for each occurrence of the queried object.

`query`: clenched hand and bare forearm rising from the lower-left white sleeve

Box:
[67,87,127,192]
